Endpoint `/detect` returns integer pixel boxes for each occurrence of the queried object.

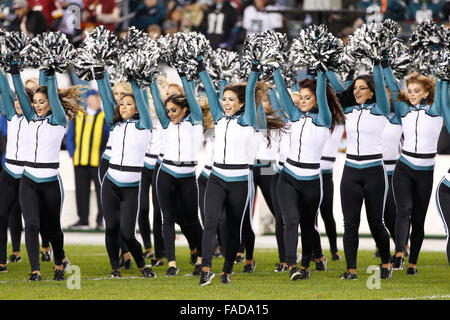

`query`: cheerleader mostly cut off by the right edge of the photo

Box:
[436,80,450,266]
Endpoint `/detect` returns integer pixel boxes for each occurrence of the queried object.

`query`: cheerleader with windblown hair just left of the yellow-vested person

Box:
[10,63,83,281]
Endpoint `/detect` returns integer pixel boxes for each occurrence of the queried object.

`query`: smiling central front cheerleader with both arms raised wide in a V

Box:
[198,57,258,286]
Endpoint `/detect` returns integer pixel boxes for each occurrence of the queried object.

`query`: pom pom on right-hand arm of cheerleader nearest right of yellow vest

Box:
[119,37,160,88]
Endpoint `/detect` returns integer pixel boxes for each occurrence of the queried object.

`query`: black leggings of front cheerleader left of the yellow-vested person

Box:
[19,175,65,272]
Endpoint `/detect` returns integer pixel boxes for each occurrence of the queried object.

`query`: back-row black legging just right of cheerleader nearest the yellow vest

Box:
[138,167,153,249]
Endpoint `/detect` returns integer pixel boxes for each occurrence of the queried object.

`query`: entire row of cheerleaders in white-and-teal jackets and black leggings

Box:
[0,48,450,285]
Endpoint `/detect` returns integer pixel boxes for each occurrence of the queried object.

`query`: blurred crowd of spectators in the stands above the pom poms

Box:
[0,0,450,50]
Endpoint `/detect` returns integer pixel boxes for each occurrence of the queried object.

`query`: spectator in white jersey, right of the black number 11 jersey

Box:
[242,0,283,35]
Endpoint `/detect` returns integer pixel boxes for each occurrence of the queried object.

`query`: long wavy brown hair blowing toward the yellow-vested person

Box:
[33,85,86,120]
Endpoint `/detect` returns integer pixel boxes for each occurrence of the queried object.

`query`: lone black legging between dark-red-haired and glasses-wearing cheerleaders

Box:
[316,173,338,258]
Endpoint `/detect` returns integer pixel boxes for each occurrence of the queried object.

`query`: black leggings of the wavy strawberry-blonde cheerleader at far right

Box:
[392,161,434,264]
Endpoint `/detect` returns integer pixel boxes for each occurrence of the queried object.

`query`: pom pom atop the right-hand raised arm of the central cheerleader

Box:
[243,31,287,72]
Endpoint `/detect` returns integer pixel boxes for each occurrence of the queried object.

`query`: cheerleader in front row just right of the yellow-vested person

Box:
[94,68,156,278]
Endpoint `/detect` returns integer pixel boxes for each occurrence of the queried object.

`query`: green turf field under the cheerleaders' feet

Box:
[0,245,450,300]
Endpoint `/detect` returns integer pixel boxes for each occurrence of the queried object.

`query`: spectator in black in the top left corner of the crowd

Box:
[9,0,47,37]
